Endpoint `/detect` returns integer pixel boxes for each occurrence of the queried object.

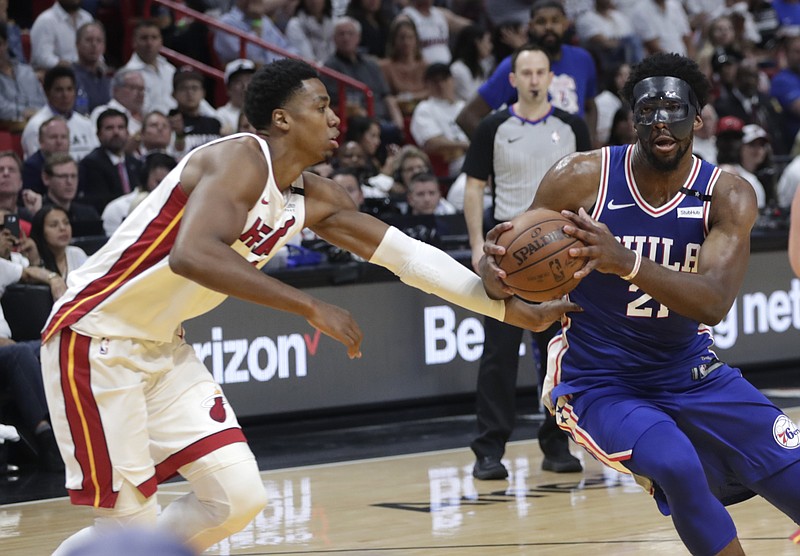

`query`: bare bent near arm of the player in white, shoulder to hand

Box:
[169,139,363,358]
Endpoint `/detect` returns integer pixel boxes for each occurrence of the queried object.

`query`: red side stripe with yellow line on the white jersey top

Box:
[42,185,187,342]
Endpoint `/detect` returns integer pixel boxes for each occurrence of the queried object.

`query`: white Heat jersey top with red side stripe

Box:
[42,134,305,342]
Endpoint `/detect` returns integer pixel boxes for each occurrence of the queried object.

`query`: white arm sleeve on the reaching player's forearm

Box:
[369,227,506,321]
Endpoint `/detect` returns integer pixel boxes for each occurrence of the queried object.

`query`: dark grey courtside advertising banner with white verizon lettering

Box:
[185,251,800,417]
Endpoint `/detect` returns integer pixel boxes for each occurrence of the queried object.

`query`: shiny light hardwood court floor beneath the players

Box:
[0,408,800,556]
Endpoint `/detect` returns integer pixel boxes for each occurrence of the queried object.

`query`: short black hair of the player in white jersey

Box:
[244,58,319,130]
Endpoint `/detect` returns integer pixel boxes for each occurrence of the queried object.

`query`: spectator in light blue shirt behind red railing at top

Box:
[214,0,300,64]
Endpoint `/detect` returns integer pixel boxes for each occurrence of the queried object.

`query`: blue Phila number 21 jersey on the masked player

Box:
[553,145,720,399]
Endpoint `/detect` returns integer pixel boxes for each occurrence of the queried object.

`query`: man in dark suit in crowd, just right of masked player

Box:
[714,58,788,154]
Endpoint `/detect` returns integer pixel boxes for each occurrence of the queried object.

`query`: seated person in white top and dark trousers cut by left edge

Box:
[0,219,66,472]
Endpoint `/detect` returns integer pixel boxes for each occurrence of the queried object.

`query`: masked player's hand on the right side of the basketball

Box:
[561,208,635,279]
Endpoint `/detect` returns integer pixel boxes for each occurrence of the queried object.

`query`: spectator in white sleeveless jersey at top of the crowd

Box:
[398,0,472,64]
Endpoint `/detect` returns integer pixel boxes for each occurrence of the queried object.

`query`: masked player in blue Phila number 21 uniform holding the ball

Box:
[481,54,800,555]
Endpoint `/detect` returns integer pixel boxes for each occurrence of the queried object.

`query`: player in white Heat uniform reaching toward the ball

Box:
[42,60,578,554]
